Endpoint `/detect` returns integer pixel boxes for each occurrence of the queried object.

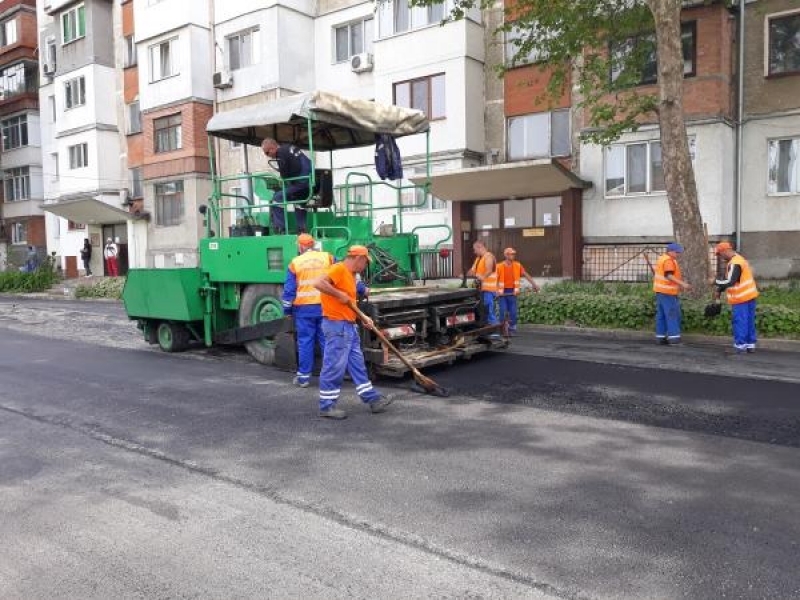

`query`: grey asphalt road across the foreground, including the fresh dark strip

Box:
[0,296,800,600]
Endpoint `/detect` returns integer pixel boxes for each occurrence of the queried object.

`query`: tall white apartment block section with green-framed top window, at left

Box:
[37,0,132,277]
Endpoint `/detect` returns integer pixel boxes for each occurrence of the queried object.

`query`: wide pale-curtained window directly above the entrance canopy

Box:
[508,109,571,160]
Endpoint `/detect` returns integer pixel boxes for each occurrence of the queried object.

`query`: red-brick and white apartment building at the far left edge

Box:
[0,0,42,270]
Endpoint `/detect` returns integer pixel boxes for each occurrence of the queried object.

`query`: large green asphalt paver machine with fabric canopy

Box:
[123,92,505,376]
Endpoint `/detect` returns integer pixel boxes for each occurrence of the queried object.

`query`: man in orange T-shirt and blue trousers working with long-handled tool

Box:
[314,246,393,420]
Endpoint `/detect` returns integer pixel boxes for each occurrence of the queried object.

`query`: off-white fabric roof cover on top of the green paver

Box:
[206,91,428,150]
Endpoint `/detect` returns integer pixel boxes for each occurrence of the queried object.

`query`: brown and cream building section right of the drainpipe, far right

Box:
[734,0,800,278]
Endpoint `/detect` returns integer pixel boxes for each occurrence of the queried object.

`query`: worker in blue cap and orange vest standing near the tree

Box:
[653,242,692,345]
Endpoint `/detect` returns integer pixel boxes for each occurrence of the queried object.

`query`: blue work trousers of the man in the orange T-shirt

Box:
[319,317,381,410]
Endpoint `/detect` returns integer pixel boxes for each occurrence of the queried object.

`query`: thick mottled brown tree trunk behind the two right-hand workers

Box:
[647,0,710,298]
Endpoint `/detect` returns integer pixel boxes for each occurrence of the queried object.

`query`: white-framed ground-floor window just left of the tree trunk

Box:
[605,141,667,196]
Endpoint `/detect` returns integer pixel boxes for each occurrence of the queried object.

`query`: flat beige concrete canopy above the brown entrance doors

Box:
[411,158,592,202]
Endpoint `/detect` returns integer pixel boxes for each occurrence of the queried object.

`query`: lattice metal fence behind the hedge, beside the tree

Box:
[581,244,720,282]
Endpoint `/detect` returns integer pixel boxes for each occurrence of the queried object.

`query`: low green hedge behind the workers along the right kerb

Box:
[519,282,800,339]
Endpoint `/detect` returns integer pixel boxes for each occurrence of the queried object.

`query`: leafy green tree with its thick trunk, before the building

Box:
[404,0,712,296]
